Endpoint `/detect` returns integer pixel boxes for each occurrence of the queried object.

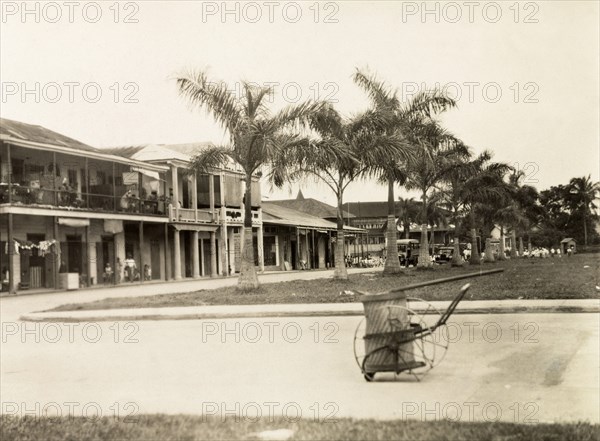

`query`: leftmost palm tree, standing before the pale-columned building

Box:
[177,71,321,291]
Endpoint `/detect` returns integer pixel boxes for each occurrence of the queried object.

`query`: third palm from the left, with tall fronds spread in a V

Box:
[354,69,456,274]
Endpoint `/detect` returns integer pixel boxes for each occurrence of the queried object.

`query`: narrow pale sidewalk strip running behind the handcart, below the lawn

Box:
[21,299,600,322]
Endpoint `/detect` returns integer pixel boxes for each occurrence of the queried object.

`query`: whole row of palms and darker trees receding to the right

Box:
[177,69,600,291]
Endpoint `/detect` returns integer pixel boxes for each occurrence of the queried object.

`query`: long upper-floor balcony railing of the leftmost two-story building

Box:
[0,183,169,216]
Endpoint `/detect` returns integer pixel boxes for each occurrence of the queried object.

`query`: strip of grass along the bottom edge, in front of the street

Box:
[0,415,600,441]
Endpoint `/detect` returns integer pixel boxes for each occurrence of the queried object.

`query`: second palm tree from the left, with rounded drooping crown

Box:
[272,105,404,279]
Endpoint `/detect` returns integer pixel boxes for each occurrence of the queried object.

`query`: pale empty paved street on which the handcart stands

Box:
[0,314,600,423]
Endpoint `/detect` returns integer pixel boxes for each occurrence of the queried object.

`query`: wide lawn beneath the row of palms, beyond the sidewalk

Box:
[49,253,600,311]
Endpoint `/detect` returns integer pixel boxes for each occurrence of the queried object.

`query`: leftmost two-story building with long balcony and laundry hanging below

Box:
[0,119,170,292]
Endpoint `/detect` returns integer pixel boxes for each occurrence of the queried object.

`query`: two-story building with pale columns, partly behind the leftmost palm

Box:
[104,143,264,280]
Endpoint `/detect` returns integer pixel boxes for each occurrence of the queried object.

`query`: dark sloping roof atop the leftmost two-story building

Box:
[0,118,96,153]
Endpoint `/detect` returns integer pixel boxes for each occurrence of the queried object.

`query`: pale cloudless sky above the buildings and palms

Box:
[0,0,600,204]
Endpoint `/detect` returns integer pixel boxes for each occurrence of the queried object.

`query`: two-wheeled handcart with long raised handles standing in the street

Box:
[354,269,504,381]
